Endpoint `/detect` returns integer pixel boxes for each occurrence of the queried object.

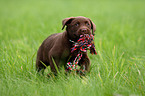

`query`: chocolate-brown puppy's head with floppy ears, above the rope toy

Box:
[62,16,96,41]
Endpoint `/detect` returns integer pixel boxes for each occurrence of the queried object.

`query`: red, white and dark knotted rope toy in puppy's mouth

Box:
[66,34,97,70]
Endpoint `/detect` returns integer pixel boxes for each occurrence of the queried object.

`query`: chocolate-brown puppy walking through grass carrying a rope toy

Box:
[36,16,96,73]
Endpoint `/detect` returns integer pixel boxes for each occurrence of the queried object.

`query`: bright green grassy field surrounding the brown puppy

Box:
[0,0,145,96]
